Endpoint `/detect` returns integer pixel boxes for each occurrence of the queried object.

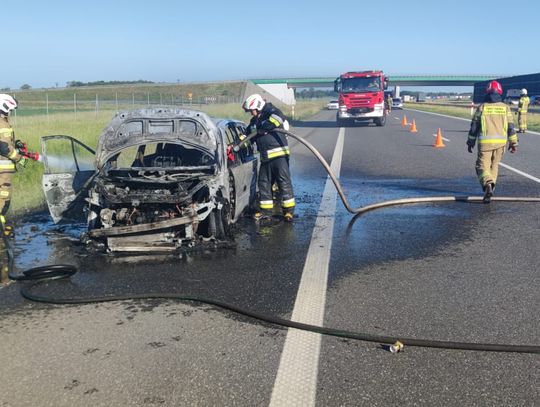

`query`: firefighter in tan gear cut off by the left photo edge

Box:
[0,94,27,236]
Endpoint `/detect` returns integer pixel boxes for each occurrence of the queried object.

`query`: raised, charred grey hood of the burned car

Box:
[96,108,220,169]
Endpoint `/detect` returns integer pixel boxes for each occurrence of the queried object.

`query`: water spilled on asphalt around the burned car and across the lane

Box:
[2,176,498,288]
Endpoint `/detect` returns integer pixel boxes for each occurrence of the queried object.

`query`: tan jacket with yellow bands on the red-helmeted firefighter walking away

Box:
[467,93,518,151]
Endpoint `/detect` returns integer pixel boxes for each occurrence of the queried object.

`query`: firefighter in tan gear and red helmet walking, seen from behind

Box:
[467,81,518,203]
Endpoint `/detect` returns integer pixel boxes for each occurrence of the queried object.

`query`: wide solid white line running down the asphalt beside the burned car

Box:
[270,127,345,407]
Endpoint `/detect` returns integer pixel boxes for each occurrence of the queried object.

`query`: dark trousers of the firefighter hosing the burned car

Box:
[258,156,295,213]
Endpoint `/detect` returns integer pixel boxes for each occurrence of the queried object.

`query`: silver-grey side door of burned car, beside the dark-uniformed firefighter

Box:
[227,122,259,219]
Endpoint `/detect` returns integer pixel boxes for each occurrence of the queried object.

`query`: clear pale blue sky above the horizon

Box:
[7,0,540,89]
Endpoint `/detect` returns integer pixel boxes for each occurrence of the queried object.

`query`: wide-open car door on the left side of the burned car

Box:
[41,136,97,223]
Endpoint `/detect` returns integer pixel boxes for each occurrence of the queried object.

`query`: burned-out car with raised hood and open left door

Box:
[41,108,258,251]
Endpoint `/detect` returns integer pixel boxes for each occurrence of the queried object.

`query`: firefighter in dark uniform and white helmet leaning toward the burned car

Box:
[242,94,296,222]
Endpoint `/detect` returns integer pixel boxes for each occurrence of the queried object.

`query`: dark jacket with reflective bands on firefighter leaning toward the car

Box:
[247,103,290,161]
